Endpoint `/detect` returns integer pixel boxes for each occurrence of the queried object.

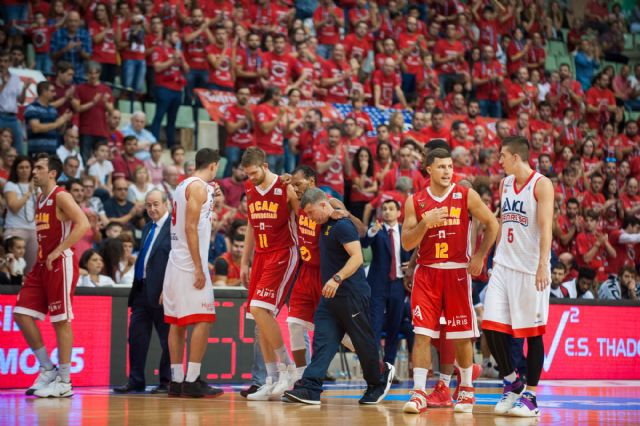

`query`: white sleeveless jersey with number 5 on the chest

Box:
[493,172,543,275]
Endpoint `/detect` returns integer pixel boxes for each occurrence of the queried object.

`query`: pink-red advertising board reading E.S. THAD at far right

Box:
[542,304,640,380]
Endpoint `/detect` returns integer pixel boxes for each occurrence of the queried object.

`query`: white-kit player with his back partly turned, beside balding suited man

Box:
[162,148,220,398]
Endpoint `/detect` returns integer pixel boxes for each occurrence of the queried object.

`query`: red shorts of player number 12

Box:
[411,265,480,339]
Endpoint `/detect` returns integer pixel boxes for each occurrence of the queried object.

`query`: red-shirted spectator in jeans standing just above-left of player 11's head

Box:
[223,87,255,176]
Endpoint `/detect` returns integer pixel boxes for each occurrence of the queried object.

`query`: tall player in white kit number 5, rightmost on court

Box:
[482,136,554,417]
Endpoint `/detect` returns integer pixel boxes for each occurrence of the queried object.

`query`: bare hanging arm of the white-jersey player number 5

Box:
[534,177,554,291]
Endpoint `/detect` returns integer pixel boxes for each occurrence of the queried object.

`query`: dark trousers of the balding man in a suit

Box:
[129,291,171,387]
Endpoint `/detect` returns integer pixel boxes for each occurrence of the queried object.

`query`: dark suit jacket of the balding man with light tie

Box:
[129,217,171,308]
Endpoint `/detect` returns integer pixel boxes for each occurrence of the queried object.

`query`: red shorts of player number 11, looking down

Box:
[247,246,298,314]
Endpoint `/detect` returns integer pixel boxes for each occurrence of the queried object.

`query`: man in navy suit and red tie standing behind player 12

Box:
[362,200,411,364]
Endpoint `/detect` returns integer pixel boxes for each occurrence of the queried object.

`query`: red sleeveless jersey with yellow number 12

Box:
[413,184,471,267]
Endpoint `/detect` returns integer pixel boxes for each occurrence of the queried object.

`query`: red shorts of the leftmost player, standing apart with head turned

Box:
[14,251,78,322]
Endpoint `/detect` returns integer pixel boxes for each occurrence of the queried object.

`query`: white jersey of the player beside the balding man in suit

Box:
[169,177,214,276]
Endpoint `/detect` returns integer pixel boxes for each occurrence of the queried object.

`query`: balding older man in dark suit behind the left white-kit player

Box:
[114,189,171,393]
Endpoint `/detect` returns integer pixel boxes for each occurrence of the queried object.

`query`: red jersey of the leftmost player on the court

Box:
[35,186,72,262]
